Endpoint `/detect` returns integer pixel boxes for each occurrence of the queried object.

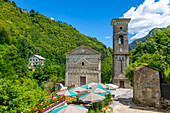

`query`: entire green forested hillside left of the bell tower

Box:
[0,0,112,112]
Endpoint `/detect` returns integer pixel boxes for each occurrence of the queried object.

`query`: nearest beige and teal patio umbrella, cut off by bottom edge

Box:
[50,104,88,113]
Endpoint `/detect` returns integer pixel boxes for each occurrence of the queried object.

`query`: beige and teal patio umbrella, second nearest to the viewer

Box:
[79,92,105,103]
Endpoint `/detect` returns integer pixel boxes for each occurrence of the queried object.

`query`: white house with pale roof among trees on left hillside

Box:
[29,55,45,70]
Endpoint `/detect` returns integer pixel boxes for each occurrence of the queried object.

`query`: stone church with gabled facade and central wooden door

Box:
[65,45,101,86]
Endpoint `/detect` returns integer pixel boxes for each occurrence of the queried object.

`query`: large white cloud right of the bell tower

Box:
[123,0,170,40]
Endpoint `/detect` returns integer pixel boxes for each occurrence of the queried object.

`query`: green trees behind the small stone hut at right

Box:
[126,28,170,83]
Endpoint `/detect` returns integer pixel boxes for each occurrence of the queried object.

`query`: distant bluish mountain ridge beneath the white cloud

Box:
[129,26,167,50]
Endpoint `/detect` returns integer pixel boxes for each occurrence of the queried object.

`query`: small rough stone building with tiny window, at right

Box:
[132,65,161,107]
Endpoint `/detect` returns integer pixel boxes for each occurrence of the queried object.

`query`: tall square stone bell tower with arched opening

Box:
[111,18,131,88]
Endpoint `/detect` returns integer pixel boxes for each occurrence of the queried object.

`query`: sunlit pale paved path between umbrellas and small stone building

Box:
[111,89,164,113]
